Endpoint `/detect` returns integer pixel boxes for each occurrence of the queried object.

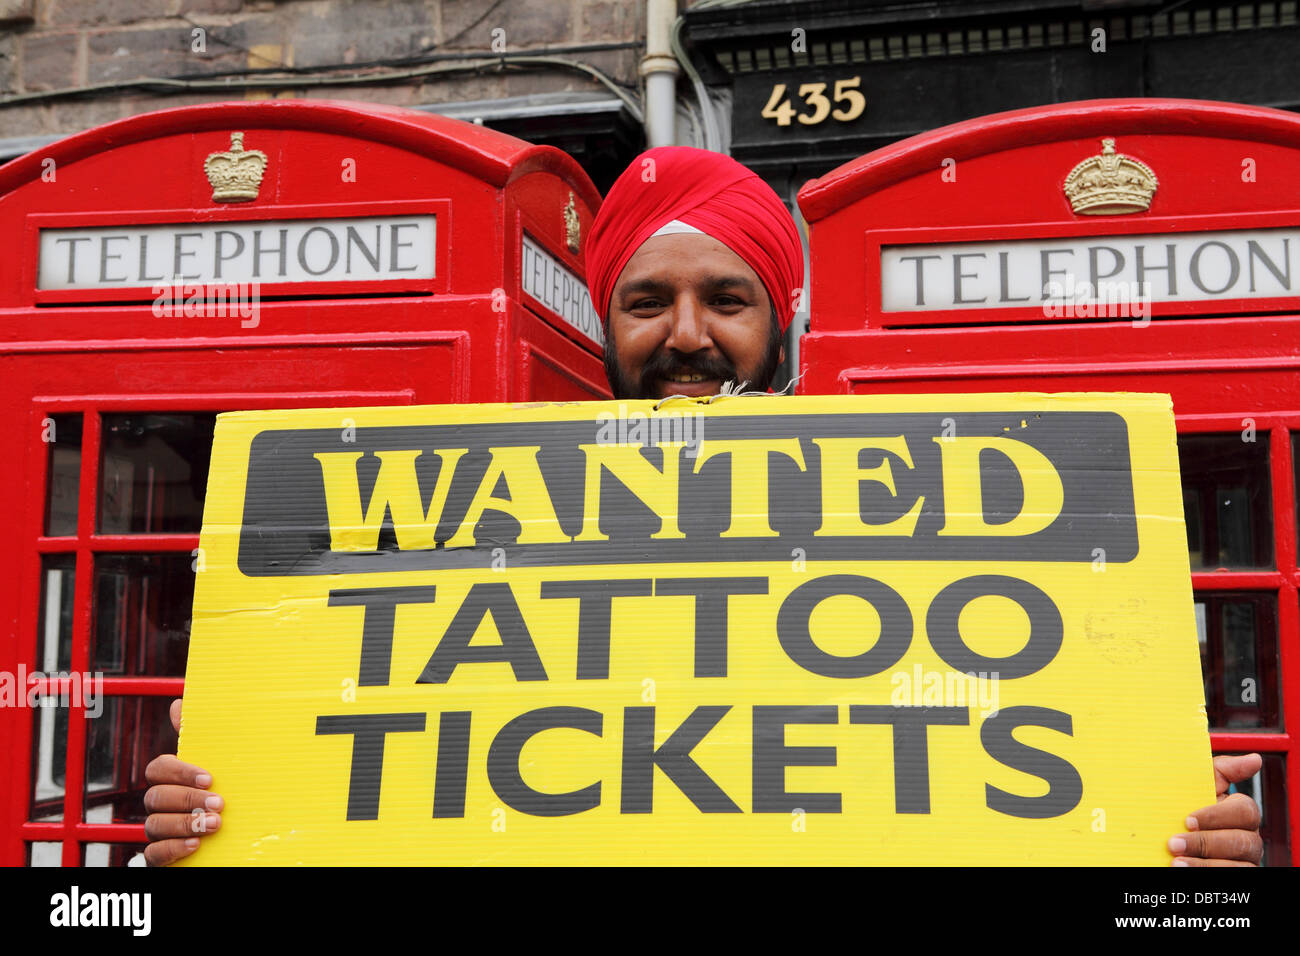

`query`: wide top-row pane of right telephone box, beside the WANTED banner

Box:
[1178,431,1274,570]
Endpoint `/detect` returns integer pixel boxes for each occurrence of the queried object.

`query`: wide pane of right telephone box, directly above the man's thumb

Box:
[1196,592,1282,730]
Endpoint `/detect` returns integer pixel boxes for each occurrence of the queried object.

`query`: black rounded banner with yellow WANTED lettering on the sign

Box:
[239,412,1138,576]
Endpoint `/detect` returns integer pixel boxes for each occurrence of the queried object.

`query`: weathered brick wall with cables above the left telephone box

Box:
[0,0,645,137]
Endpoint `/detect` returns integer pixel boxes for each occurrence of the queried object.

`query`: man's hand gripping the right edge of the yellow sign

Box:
[1169,753,1264,866]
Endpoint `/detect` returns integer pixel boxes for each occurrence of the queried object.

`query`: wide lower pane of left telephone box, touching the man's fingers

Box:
[85,697,177,823]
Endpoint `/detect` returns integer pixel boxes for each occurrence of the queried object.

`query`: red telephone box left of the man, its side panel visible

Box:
[0,100,608,865]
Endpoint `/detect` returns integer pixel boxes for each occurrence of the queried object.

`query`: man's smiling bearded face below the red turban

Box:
[605,233,785,398]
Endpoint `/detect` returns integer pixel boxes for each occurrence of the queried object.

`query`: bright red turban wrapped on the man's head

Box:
[585,146,803,330]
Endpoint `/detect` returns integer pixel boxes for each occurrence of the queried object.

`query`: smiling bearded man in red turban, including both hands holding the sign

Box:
[144,147,1262,866]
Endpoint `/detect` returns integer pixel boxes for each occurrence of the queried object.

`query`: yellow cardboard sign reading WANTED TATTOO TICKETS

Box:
[181,394,1214,865]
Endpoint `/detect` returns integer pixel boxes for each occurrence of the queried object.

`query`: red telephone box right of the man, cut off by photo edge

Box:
[798,99,1300,865]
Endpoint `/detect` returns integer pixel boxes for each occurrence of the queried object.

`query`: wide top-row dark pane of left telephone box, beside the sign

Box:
[99,414,216,535]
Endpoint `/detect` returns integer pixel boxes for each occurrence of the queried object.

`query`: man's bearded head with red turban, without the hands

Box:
[585,147,803,398]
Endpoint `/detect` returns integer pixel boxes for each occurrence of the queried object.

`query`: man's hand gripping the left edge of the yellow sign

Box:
[144,700,225,866]
